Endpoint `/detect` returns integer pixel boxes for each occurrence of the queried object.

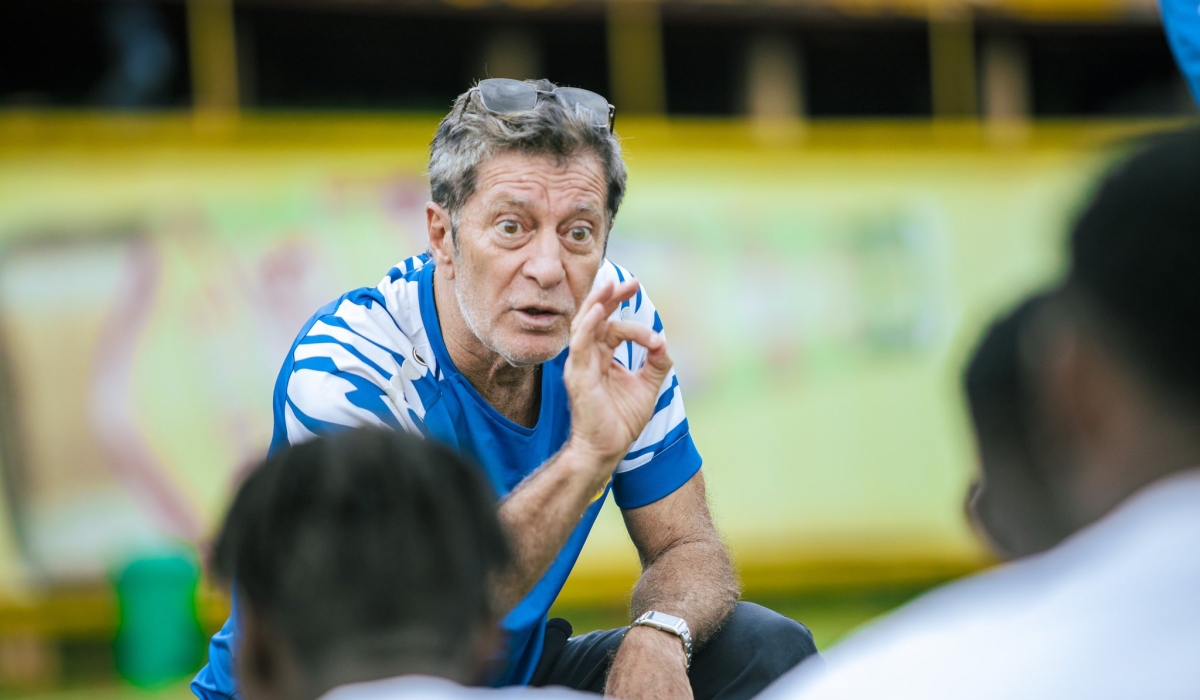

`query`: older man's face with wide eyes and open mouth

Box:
[454,154,608,366]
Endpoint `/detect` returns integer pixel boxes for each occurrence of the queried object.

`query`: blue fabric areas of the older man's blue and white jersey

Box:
[192,259,701,700]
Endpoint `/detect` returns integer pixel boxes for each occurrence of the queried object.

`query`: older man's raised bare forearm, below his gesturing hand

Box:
[493,442,616,612]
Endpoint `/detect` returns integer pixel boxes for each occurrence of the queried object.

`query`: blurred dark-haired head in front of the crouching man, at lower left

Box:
[214,430,509,700]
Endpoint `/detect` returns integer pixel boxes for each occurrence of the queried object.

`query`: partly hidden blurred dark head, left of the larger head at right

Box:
[964,294,1067,558]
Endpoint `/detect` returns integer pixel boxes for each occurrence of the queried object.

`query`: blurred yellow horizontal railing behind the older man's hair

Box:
[0,110,1196,157]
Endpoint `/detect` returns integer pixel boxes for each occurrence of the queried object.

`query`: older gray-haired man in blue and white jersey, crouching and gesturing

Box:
[192,79,816,700]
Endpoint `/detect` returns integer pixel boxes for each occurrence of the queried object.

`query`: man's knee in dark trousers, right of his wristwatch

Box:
[713,603,817,674]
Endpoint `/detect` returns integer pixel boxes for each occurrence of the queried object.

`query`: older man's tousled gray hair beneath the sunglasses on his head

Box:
[428,80,626,228]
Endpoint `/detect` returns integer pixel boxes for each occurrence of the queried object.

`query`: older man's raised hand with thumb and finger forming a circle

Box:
[563,280,673,473]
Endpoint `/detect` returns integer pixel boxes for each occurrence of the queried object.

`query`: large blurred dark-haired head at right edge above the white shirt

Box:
[1034,131,1200,542]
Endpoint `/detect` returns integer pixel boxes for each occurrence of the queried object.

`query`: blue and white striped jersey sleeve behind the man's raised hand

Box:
[605,262,702,509]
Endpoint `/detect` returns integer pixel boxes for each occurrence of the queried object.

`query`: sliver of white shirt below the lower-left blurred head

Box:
[320,676,595,700]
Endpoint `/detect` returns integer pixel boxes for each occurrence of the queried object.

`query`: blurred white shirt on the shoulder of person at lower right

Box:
[760,469,1200,700]
